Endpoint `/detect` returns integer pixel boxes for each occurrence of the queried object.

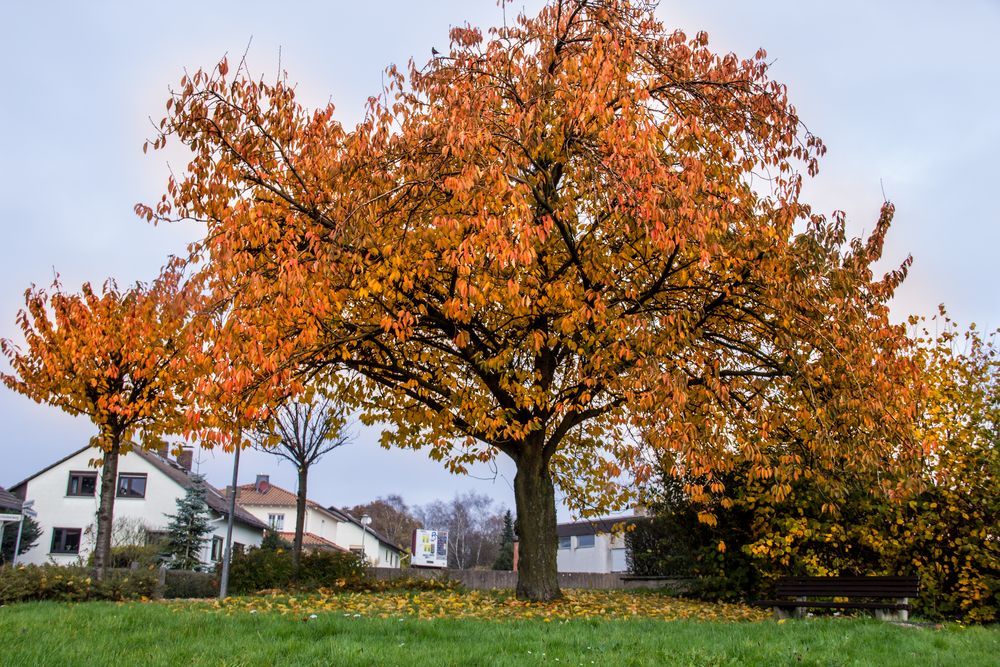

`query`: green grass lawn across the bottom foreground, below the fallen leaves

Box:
[0,602,1000,667]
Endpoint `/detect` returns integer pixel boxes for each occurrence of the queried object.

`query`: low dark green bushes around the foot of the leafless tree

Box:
[229,549,367,594]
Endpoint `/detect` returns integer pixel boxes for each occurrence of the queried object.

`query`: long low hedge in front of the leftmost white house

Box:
[0,565,157,604]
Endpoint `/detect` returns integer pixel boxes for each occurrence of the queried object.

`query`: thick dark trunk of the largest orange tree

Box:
[514,443,562,601]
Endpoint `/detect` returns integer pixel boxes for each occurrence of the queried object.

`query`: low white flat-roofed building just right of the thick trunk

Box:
[556,515,635,573]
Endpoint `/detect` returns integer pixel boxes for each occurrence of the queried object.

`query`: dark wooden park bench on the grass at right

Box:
[754,577,920,621]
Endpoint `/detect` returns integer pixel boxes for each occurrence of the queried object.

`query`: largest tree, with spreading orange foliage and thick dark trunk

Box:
[137,0,911,599]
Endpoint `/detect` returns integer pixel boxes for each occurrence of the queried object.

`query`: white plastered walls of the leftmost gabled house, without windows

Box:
[18,448,262,565]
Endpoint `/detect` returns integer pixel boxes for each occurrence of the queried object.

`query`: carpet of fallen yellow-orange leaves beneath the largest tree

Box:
[169,590,769,622]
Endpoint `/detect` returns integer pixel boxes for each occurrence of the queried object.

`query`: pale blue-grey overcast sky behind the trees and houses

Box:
[0,0,1000,518]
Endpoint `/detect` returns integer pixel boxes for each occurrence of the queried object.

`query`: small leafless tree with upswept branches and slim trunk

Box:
[251,395,350,573]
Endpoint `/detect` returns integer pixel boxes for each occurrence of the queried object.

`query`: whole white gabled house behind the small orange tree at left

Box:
[10,447,267,565]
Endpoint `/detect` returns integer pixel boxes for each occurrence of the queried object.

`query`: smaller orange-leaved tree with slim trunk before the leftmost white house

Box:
[0,270,191,574]
